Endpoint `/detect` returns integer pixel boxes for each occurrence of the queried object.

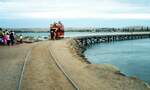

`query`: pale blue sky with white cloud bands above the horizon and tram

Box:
[0,0,150,27]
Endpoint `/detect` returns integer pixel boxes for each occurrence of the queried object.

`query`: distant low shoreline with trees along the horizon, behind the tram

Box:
[2,26,150,32]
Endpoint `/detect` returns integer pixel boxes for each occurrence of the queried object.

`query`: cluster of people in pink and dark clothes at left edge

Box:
[0,28,15,45]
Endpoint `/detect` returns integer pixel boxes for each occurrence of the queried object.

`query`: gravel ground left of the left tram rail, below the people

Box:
[0,45,31,90]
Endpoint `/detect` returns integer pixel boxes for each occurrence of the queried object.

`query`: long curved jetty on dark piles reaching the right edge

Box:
[74,32,150,46]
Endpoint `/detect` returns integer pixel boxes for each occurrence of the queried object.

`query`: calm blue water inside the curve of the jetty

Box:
[85,39,150,84]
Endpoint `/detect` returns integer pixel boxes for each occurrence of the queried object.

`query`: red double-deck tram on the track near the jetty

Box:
[50,21,64,40]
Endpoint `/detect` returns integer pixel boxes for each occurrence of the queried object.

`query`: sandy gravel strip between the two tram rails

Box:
[22,42,74,90]
